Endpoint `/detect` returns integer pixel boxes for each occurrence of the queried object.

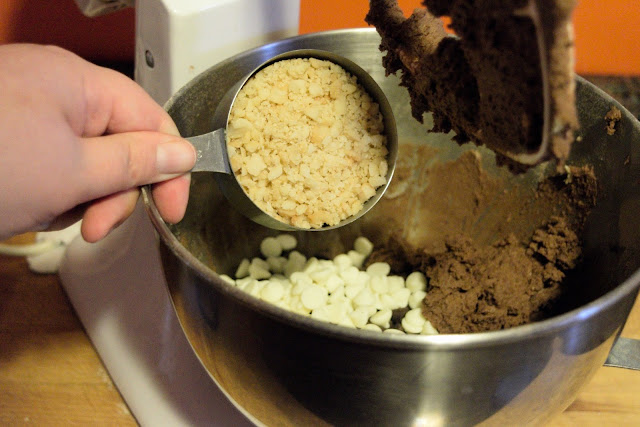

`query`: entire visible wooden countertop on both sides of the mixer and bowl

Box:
[0,236,640,427]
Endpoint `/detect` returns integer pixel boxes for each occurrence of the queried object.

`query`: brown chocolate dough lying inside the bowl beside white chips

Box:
[368,152,597,333]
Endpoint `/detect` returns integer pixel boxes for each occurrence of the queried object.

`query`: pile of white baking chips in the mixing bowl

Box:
[221,234,438,335]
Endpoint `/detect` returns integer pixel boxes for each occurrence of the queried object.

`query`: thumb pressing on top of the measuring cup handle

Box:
[78,131,196,201]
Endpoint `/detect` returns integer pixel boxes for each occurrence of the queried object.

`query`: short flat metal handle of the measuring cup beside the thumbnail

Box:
[186,128,231,174]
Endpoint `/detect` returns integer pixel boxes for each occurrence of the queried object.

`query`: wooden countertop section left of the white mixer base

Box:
[0,236,136,426]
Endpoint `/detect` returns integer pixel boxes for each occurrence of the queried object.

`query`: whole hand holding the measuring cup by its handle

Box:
[0,44,195,242]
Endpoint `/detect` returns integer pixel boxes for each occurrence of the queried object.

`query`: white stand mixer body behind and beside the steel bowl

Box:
[59,0,300,426]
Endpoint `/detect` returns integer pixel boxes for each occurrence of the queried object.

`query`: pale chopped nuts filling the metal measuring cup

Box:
[227,58,388,228]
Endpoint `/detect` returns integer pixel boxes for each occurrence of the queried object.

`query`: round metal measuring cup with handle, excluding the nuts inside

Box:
[186,49,398,231]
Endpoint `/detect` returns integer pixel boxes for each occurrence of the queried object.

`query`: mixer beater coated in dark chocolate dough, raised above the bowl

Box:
[366,0,578,170]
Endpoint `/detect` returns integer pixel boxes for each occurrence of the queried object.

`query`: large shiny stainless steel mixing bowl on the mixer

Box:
[144,29,640,426]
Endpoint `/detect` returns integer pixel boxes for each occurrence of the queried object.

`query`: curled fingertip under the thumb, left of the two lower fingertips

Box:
[80,188,140,243]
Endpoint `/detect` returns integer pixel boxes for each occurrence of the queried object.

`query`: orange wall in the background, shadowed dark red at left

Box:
[0,0,640,75]
